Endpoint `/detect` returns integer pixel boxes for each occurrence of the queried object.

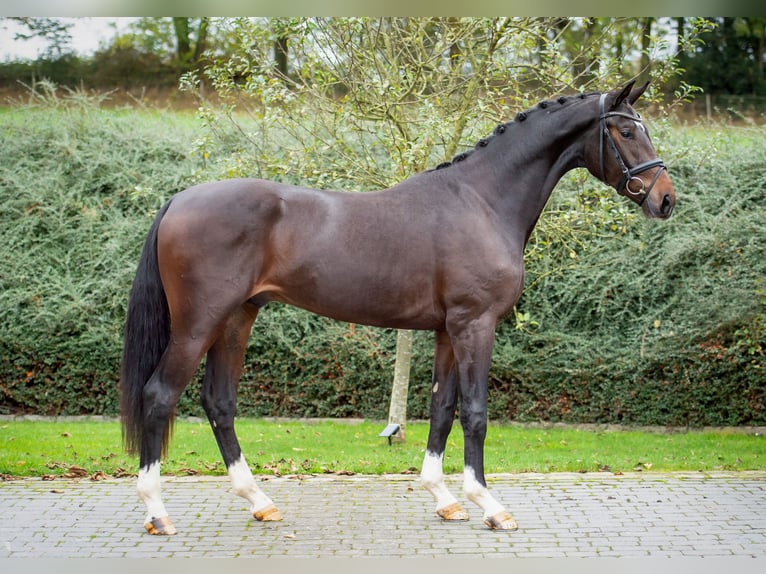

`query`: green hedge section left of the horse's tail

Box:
[0,98,198,414]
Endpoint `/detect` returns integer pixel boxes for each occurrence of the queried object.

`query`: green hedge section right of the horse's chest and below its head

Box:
[493,124,766,426]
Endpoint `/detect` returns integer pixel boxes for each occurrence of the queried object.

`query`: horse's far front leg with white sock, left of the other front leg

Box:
[420,331,468,520]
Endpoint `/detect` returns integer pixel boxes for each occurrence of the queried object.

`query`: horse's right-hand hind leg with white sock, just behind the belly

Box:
[202,303,282,522]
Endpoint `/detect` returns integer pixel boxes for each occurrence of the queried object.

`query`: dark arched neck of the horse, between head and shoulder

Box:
[466,97,598,243]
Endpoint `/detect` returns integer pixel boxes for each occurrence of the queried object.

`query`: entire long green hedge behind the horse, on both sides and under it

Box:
[0,101,766,426]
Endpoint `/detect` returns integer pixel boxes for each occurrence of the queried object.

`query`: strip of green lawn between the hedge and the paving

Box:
[0,419,766,478]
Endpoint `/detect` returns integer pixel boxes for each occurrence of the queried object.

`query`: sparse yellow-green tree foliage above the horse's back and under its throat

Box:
[184,18,706,290]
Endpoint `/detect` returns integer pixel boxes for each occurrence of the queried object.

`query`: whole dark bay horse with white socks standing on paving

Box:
[120,82,675,535]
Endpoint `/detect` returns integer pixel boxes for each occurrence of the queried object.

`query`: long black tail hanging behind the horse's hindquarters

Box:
[120,201,170,453]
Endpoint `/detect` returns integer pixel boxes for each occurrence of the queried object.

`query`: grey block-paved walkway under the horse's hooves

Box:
[0,472,766,558]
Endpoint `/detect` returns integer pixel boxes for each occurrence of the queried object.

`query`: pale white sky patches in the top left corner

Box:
[0,17,135,62]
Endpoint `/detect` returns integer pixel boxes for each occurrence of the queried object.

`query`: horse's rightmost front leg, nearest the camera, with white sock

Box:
[452,320,518,531]
